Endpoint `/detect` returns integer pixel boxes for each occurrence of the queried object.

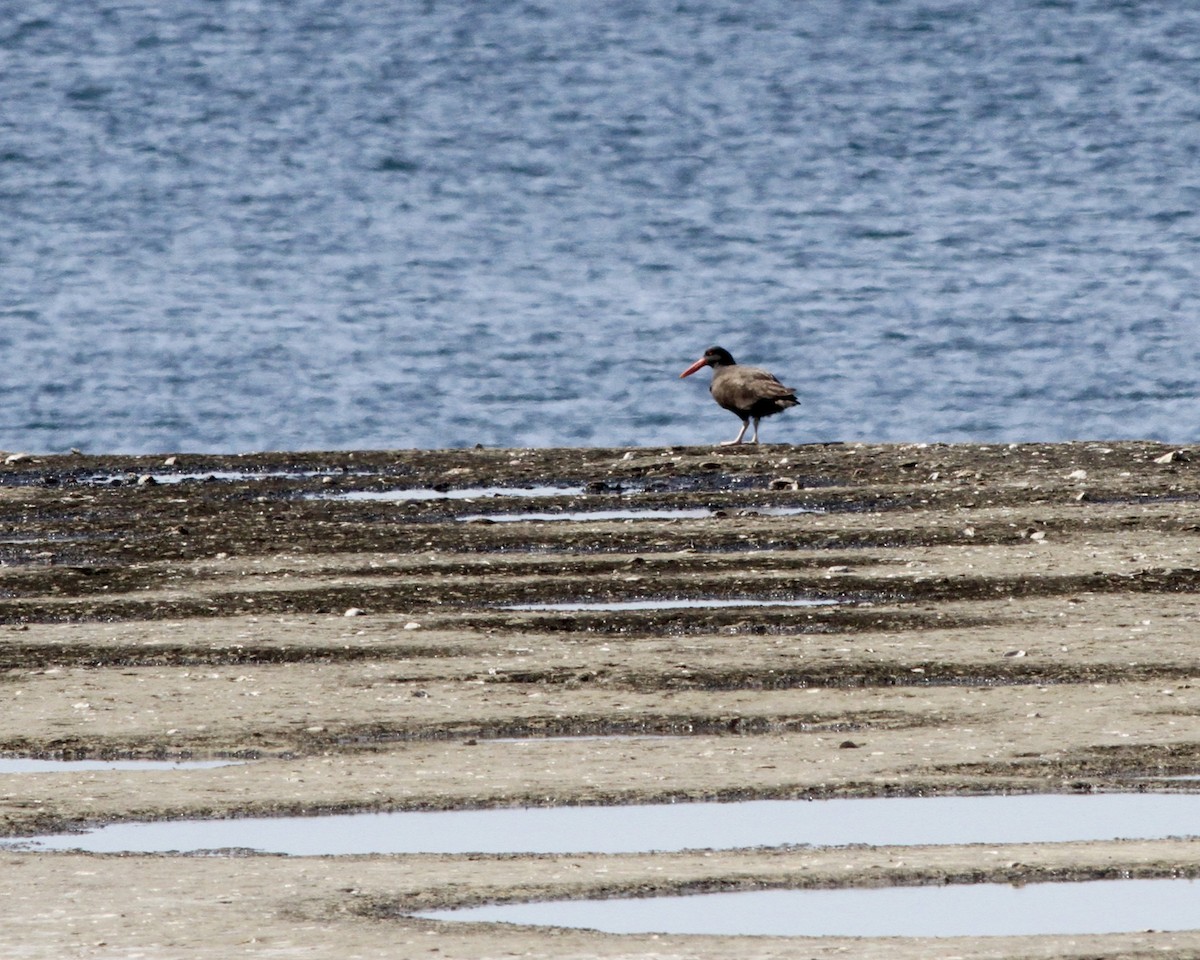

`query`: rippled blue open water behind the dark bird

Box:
[0,0,1200,452]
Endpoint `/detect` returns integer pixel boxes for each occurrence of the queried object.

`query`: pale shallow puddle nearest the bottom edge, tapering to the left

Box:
[418,880,1200,937]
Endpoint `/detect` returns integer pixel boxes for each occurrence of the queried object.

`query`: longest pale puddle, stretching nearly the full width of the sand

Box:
[11,793,1200,857]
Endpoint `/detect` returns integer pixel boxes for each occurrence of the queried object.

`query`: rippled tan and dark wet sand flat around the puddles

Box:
[0,443,1200,958]
